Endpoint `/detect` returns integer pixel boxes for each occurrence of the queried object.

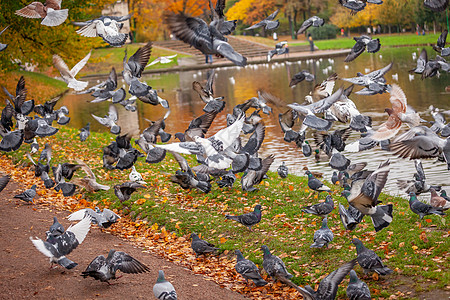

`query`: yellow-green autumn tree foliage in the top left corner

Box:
[0,0,114,70]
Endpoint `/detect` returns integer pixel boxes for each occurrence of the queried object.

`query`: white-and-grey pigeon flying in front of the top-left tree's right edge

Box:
[72,14,132,47]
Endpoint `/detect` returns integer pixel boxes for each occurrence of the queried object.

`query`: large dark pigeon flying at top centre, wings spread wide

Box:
[164,1,247,67]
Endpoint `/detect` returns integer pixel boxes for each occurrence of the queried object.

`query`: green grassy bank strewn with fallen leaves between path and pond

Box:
[7,128,450,299]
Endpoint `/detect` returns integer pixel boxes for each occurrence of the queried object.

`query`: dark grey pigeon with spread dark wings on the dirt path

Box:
[81,249,150,284]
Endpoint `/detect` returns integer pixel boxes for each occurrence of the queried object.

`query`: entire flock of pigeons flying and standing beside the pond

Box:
[0,0,450,299]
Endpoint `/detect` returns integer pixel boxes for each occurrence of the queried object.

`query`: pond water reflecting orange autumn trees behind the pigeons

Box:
[59,47,450,194]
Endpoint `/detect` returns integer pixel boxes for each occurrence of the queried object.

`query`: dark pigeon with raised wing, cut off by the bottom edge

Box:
[299,259,356,300]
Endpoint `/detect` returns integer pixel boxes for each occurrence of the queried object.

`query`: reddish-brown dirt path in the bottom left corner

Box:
[0,182,245,300]
